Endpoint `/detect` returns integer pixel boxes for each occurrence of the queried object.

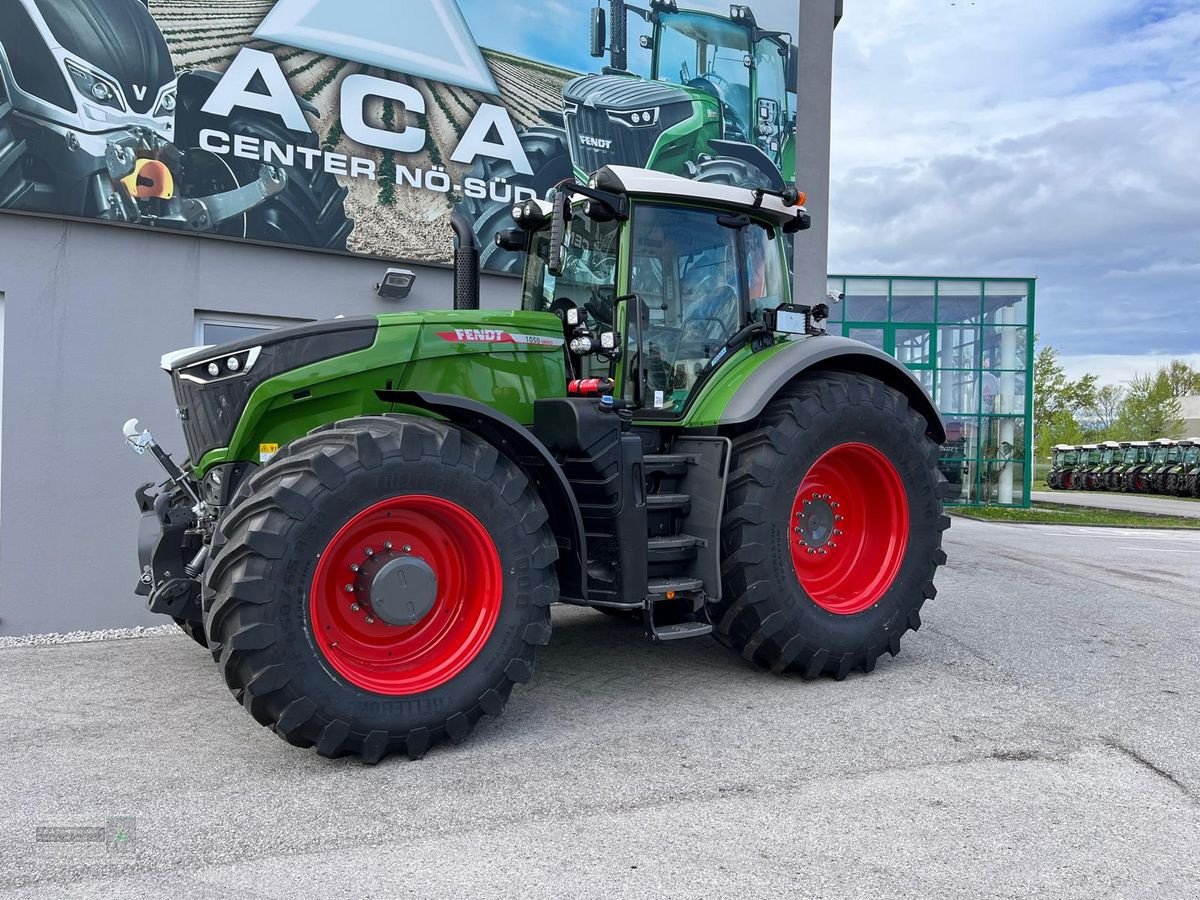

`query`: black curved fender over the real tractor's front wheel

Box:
[376,390,588,601]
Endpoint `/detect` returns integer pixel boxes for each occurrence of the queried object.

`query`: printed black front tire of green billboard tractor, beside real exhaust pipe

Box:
[462,126,575,272]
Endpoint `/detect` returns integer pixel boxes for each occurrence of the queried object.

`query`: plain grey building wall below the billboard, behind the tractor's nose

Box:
[0,214,518,635]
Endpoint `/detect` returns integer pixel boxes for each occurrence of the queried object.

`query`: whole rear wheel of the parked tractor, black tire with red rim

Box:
[709,372,949,679]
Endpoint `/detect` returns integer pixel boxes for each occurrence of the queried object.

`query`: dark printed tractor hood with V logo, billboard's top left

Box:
[37,0,175,114]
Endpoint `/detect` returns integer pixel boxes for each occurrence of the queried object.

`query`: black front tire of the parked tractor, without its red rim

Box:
[204,415,558,763]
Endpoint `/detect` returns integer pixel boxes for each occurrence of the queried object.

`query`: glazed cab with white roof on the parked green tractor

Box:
[513,167,820,420]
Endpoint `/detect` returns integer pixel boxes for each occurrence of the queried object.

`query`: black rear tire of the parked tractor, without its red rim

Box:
[709,372,950,680]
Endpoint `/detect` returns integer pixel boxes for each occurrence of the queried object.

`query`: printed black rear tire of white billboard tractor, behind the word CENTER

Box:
[175,73,354,251]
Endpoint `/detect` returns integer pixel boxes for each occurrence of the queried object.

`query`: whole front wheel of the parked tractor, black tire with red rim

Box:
[205,416,558,762]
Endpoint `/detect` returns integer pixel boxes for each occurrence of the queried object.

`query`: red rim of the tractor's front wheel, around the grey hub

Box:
[308,494,504,695]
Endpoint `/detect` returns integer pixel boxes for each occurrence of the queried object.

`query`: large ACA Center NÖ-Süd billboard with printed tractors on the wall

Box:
[0,0,798,271]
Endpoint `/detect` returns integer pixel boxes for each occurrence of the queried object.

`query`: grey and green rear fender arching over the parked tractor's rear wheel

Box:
[694,335,946,444]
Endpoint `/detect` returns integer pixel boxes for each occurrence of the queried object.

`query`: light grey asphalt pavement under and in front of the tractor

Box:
[0,518,1200,900]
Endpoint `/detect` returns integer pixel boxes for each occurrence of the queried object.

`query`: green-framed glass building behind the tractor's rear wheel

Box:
[828,275,1036,506]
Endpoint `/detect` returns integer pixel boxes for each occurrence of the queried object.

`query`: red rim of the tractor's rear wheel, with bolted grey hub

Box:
[787,444,908,616]
